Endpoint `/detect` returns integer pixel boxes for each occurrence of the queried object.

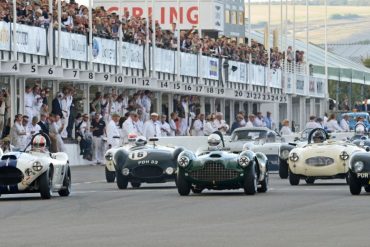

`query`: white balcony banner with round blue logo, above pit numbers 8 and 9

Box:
[92,37,117,65]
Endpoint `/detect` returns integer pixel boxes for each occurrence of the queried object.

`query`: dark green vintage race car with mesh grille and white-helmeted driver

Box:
[176,133,269,196]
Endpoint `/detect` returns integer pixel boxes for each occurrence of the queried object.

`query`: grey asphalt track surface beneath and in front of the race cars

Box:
[0,166,370,247]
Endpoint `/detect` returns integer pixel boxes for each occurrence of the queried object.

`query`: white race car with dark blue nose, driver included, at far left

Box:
[0,133,71,199]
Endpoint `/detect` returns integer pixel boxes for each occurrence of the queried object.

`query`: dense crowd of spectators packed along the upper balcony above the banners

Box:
[0,0,304,69]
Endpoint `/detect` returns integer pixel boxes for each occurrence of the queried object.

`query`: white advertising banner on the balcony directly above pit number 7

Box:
[55,31,88,62]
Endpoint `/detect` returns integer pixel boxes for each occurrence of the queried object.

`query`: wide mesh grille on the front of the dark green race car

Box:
[189,162,239,182]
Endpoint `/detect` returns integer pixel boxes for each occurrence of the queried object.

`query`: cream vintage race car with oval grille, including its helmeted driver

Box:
[288,128,363,185]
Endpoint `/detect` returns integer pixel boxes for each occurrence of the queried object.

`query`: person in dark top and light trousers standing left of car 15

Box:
[91,113,105,164]
